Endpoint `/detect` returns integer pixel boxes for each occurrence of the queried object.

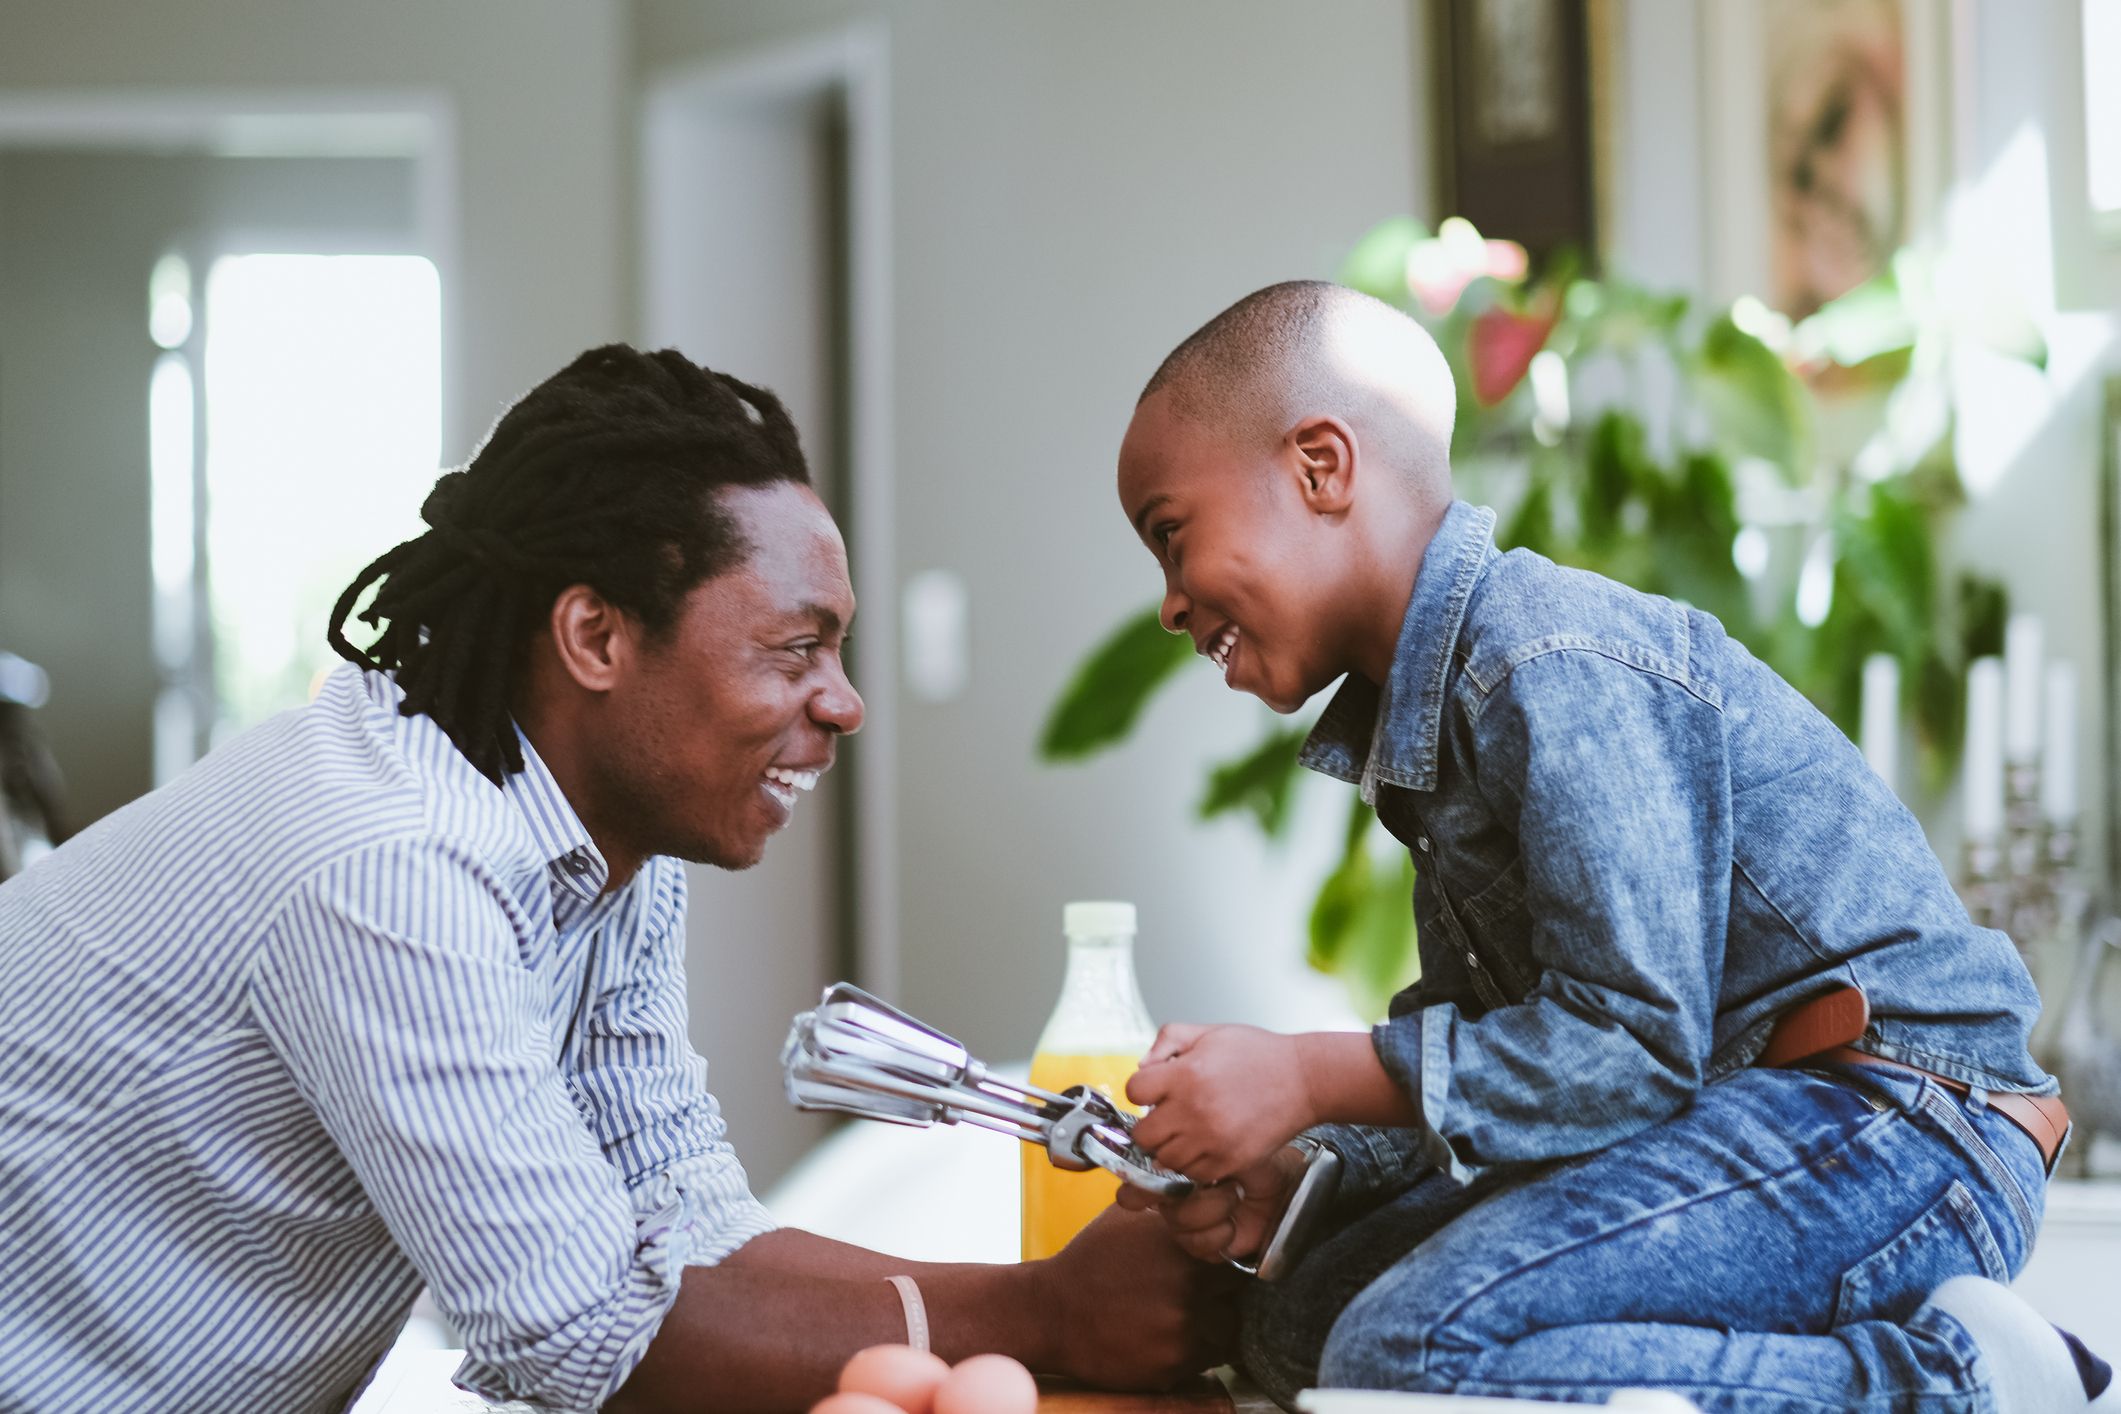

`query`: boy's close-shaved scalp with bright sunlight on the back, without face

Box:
[1137,280,1457,502]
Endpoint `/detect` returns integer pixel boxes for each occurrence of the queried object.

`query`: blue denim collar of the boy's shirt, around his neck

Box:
[1298,500,1495,806]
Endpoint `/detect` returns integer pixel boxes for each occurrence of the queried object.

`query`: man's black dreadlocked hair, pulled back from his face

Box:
[325,343,810,784]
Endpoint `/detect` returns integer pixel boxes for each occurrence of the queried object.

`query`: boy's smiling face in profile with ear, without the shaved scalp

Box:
[1120,392,1353,712]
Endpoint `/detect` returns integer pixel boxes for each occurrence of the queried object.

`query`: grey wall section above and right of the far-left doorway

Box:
[0,0,632,460]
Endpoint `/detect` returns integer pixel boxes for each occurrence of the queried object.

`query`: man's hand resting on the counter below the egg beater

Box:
[1037,1210,1243,1389]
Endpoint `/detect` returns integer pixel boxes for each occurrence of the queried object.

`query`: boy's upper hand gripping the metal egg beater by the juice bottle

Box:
[1126,1024,1317,1183]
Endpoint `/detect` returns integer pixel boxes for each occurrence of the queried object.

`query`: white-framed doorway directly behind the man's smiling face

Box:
[638,30,897,1191]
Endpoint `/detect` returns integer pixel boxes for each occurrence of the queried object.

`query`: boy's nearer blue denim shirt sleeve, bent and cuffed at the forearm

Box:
[1372,651,1731,1181]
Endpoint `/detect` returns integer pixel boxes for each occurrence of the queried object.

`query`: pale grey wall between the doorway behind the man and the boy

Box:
[636,0,1427,1056]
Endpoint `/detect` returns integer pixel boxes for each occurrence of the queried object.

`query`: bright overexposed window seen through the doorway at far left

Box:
[151,254,441,778]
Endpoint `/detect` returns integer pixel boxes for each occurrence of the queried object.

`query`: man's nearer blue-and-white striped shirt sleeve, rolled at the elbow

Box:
[250,839,696,1410]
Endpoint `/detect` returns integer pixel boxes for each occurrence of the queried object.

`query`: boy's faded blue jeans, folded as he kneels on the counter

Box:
[1245,1066,2047,1414]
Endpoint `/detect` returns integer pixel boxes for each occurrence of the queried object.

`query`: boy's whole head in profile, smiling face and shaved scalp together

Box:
[1118,280,1457,712]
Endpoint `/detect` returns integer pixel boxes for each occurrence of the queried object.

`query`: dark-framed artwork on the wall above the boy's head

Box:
[1430,0,1597,261]
